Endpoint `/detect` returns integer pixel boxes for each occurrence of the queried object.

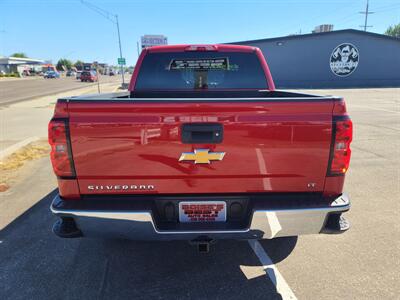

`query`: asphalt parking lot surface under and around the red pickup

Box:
[0,89,400,299]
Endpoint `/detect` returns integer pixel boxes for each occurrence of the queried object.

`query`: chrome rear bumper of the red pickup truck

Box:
[50,194,350,240]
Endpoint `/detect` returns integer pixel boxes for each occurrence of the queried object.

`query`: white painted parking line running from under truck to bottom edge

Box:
[249,240,297,300]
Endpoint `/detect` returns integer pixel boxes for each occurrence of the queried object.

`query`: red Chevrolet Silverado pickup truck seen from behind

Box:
[49,45,352,249]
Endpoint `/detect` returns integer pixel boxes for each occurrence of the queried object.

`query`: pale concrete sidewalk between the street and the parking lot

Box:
[0,83,119,153]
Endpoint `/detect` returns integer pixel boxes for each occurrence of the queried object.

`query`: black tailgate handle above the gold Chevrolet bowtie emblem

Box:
[182,123,224,144]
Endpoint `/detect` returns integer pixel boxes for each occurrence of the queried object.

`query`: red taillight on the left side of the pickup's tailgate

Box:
[49,119,75,177]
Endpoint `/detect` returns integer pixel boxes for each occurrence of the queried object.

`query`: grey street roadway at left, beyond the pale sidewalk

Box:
[0,75,121,106]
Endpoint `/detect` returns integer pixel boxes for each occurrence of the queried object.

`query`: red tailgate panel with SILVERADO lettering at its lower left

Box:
[68,99,334,194]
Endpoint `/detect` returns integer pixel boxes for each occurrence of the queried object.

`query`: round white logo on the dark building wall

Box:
[330,43,360,77]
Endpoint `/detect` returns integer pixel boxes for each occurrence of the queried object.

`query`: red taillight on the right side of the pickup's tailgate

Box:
[328,116,353,176]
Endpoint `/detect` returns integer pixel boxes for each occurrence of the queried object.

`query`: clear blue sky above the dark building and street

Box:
[0,0,400,65]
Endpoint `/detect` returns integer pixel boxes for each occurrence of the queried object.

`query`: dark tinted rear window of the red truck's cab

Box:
[135,51,267,90]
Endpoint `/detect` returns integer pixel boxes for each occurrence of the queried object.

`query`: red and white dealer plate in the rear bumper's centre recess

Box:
[179,201,226,223]
